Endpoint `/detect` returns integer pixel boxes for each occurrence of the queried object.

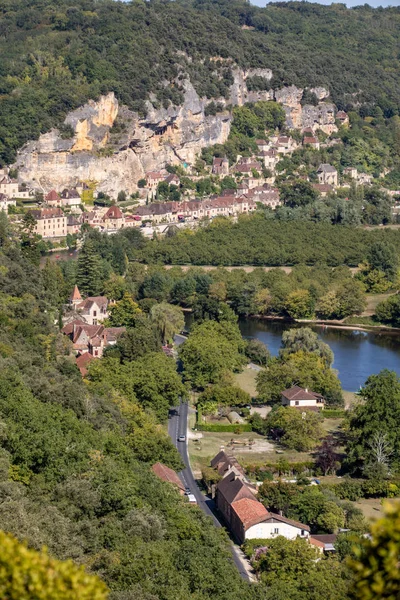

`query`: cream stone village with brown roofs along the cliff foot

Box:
[0,111,396,240]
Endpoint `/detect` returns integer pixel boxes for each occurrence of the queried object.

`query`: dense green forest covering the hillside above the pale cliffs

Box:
[0,0,400,163]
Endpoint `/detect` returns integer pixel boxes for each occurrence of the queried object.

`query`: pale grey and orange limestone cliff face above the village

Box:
[15,67,336,197]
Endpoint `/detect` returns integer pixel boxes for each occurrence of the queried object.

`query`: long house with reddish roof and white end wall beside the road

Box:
[216,472,310,544]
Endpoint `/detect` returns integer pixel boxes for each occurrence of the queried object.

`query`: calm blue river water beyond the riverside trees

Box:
[239,319,400,392]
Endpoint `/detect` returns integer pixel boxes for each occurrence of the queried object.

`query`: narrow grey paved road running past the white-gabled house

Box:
[168,402,252,581]
